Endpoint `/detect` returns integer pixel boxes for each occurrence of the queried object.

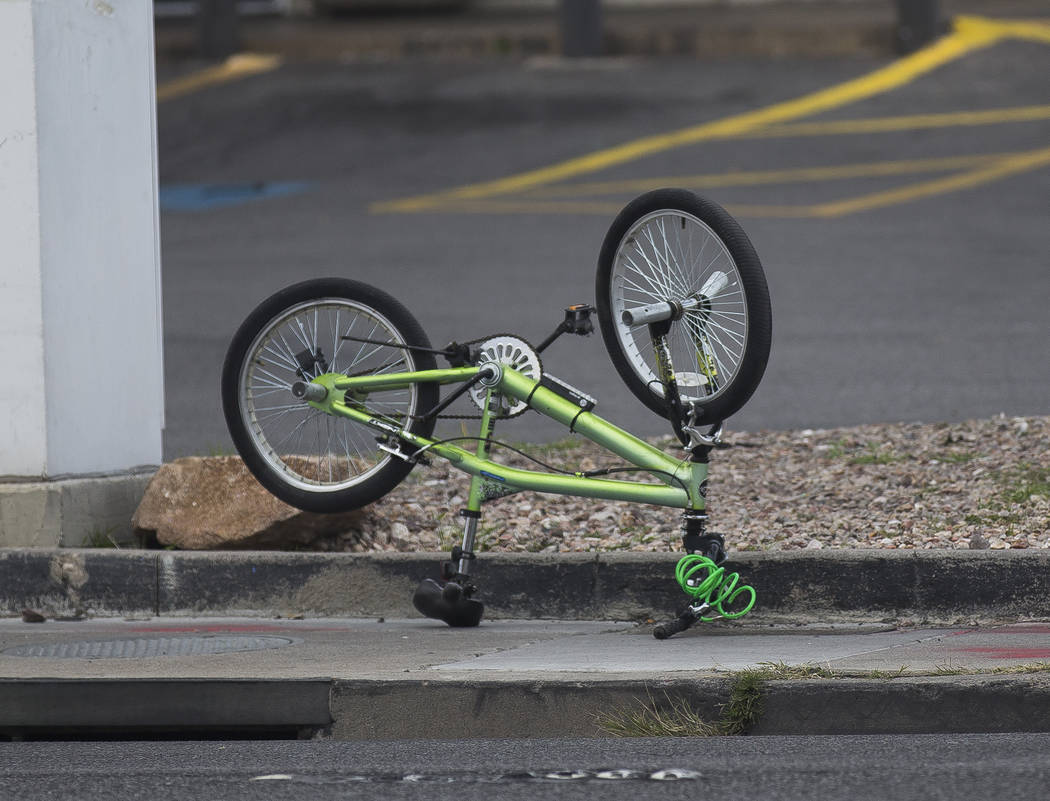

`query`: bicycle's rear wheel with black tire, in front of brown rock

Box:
[222,278,438,512]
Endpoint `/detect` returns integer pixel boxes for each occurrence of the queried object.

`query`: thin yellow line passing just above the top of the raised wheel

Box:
[522,153,1014,198]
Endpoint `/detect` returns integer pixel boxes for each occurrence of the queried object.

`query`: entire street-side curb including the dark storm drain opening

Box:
[0,674,1050,740]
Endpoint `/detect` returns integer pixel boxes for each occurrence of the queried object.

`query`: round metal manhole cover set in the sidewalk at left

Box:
[0,635,296,659]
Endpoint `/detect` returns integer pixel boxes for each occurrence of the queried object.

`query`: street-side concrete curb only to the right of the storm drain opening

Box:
[330,675,1050,740]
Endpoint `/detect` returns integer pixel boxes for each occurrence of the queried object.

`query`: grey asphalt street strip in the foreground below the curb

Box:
[0,734,1050,801]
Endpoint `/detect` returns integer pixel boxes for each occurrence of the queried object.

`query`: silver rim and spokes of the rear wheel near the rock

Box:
[238,298,418,492]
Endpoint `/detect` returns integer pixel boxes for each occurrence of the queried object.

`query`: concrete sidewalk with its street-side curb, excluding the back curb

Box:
[0,618,1050,739]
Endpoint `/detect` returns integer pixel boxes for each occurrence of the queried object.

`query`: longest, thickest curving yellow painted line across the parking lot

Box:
[371,18,1004,213]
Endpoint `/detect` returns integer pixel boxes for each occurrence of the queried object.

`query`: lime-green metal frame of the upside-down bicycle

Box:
[309,365,708,513]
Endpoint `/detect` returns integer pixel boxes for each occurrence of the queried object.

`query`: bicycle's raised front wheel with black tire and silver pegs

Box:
[595,189,773,423]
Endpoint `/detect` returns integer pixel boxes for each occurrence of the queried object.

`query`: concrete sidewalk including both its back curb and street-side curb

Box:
[0,550,1050,739]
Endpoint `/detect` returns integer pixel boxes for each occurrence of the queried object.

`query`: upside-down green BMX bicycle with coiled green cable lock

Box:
[222,189,772,638]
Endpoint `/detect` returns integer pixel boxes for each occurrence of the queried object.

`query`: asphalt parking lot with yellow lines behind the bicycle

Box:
[152,0,1050,460]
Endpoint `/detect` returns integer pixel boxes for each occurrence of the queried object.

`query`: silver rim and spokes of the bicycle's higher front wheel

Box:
[609,209,748,403]
